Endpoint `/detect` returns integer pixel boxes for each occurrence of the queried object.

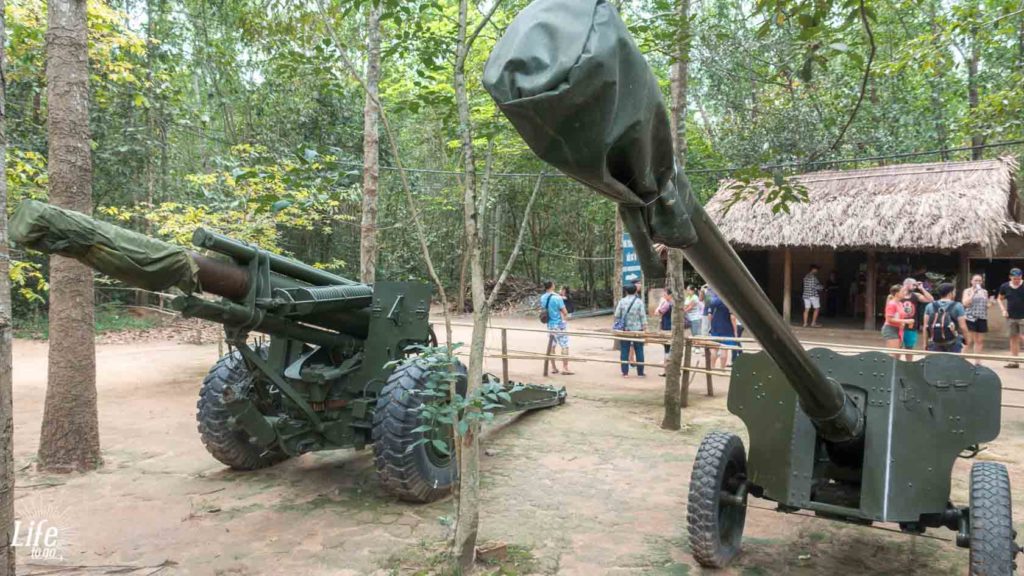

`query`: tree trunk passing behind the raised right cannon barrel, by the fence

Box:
[662,0,690,430]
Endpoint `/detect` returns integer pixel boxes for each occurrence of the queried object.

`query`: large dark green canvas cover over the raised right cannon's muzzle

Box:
[483,0,697,279]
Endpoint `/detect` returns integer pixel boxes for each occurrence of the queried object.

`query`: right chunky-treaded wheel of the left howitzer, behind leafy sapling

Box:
[373,361,466,502]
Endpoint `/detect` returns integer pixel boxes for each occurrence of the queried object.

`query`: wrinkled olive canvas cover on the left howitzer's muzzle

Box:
[8,200,200,292]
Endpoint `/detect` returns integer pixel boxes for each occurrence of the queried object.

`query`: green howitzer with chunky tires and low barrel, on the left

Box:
[10,201,565,502]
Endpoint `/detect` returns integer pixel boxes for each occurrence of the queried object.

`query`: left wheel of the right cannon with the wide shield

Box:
[686,431,746,568]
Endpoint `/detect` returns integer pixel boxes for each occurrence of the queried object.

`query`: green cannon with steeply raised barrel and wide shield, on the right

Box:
[483,0,1019,576]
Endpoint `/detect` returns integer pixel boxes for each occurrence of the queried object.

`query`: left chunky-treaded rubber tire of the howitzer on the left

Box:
[196,349,288,470]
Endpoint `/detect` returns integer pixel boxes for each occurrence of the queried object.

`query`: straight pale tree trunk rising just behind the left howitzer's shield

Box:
[359,2,381,284]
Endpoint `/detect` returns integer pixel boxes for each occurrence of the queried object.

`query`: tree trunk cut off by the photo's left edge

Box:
[0,0,14,576]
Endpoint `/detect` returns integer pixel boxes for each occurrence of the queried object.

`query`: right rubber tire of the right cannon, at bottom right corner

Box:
[968,462,1018,576]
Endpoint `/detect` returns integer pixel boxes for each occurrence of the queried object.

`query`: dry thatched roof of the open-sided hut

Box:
[707,157,1024,254]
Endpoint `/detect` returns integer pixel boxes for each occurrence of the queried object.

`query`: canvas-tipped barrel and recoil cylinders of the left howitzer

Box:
[10,200,373,338]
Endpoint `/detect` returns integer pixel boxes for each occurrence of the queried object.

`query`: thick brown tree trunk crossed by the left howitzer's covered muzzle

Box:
[39,0,102,471]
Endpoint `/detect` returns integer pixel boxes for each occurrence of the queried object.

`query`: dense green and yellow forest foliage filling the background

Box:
[6,0,1024,315]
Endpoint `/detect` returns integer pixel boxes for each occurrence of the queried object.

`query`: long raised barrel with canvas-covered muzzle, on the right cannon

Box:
[483,0,863,442]
